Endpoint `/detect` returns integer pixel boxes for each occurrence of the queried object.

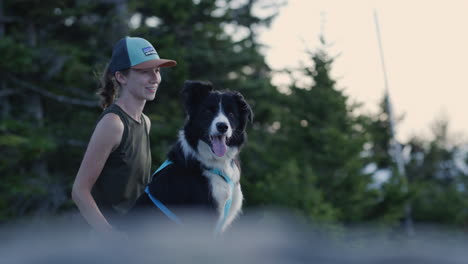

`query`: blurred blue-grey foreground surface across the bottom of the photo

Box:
[0,210,468,264]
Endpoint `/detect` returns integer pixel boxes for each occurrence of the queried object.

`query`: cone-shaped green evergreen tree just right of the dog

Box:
[243,41,377,223]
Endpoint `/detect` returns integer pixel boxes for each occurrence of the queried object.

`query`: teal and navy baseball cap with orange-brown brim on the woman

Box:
[109,37,177,74]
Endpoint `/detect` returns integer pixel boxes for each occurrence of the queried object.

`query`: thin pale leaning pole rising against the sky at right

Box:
[374,10,414,235]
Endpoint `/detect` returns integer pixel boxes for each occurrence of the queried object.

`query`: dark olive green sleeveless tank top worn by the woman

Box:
[91,104,151,218]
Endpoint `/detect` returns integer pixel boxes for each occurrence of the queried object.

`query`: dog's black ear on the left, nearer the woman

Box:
[182,80,213,114]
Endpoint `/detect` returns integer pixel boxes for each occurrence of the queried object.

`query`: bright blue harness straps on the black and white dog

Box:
[145,160,234,234]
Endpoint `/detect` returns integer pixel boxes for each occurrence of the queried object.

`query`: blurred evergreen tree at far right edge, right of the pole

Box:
[407,119,468,227]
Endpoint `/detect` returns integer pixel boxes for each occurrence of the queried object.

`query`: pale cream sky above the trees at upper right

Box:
[260,0,468,140]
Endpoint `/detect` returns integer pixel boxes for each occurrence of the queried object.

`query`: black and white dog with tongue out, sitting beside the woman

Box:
[136,81,253,232]
